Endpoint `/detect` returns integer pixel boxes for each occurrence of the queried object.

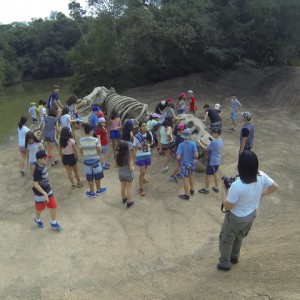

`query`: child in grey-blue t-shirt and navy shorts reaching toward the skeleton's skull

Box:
[198,128,223,194]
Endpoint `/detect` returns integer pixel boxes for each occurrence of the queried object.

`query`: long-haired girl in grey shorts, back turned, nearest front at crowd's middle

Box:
[116,141,134,208]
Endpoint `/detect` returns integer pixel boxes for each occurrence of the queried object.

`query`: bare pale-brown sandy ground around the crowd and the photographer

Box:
[0,69,300,300]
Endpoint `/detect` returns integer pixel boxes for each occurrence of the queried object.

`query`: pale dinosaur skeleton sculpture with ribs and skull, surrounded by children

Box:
[77,86,213,169]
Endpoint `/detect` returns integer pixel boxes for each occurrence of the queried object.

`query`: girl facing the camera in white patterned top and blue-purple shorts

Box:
[133,121,153,196]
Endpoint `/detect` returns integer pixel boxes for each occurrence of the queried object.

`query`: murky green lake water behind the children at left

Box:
[0,78,72,148]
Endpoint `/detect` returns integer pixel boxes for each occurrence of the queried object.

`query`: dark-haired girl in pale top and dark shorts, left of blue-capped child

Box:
[159,118,175,173]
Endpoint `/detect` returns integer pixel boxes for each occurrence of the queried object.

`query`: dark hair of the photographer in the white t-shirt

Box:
[238,150,258,184]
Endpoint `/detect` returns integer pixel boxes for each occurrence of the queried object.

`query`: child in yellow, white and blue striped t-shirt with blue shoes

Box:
[79,124,106,198]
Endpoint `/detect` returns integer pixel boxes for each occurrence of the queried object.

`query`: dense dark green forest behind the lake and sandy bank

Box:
[0,0,300,94]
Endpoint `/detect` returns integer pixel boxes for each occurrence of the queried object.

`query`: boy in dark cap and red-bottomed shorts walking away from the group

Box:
[32,150,62,231]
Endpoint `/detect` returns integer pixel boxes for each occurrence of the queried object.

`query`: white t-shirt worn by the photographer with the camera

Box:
[227,171,274,217]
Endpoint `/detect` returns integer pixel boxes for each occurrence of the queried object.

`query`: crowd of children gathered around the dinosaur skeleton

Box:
[18,86,252,231]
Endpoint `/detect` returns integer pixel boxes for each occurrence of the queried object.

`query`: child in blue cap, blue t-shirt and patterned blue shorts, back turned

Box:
[176,129,198,200]
